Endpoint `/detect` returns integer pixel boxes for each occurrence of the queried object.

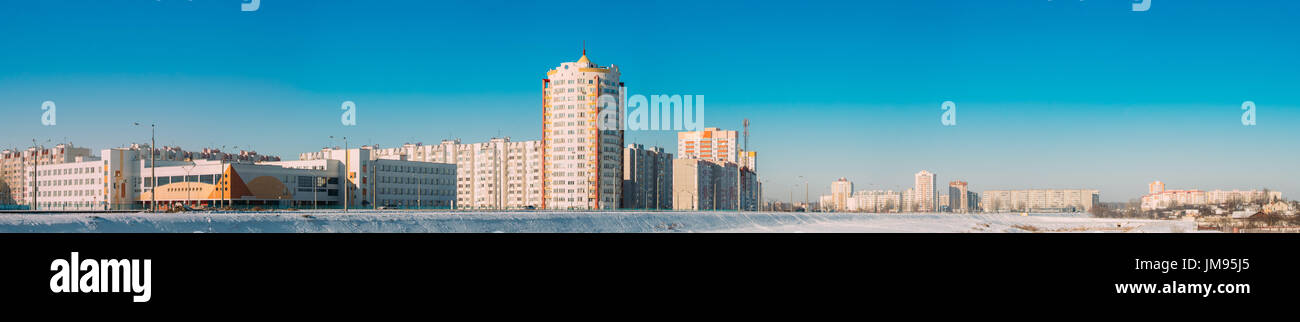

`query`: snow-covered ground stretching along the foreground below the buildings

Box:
[0,210,1196,232]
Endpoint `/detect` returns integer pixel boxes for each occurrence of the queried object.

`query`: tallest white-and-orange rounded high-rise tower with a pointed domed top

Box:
[542,49,624,209]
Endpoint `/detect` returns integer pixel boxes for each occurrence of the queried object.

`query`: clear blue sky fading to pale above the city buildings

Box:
[0,0,1300,201]
